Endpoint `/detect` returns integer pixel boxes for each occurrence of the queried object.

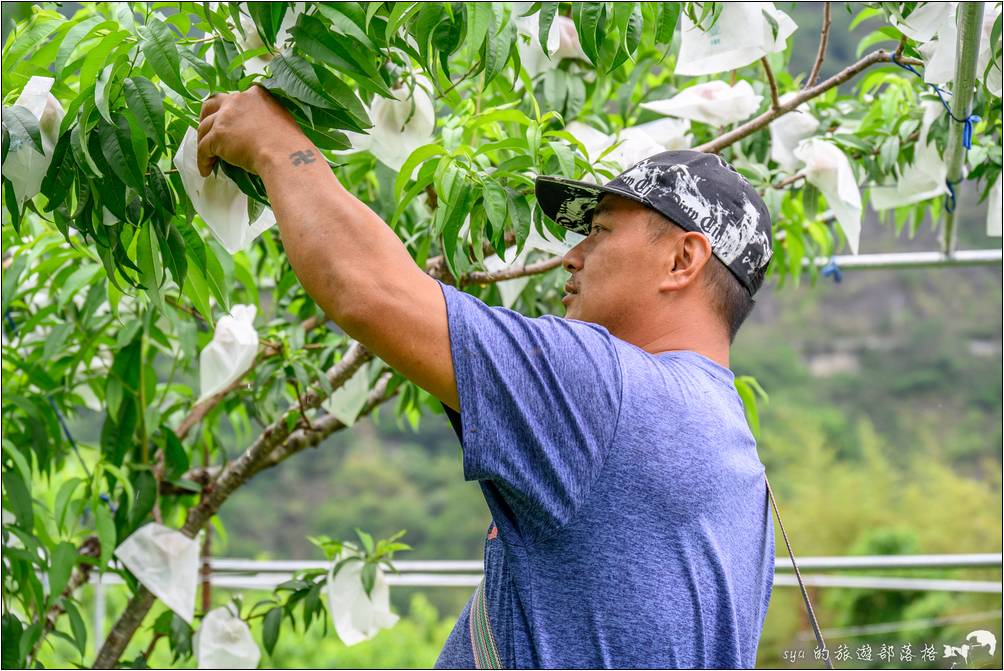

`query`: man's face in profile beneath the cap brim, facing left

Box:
[561,195,672,334]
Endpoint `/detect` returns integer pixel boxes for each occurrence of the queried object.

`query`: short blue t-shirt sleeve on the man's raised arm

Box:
[441,283,621,540]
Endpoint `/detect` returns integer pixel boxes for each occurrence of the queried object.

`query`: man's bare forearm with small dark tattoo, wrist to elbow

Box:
[259,139,425,329]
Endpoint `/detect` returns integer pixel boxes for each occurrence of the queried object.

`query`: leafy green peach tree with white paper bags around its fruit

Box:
[2,2,1001,668]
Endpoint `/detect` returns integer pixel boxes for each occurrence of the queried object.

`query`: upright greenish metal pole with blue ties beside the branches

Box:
[942,2,983,256]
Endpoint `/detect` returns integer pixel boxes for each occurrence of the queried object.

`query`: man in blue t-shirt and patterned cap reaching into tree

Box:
[199,86,774,668]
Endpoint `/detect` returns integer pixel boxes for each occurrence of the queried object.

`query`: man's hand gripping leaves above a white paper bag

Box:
[198,84,310,177]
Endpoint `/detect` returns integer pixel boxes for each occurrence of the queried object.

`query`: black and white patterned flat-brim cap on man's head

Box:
[536,151,773,295]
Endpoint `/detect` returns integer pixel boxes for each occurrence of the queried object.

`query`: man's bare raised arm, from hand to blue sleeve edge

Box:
[199,85,460,410]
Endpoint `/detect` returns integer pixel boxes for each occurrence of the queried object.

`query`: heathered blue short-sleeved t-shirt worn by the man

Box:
[436,284,774,668]
